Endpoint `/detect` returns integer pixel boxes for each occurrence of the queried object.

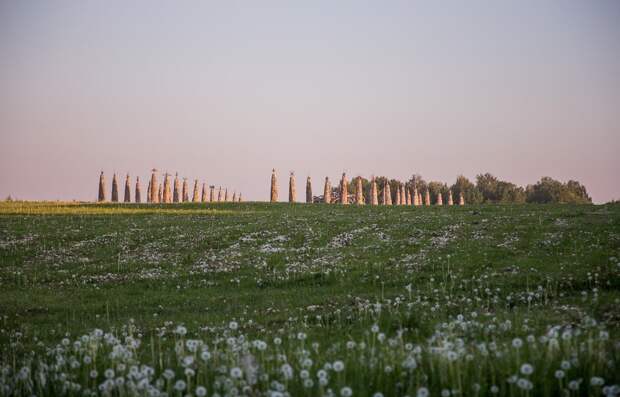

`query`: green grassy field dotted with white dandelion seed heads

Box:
[0,202,620,397]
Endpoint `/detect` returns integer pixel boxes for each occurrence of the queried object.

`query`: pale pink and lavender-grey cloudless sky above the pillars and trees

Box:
[0,0,620,202]
